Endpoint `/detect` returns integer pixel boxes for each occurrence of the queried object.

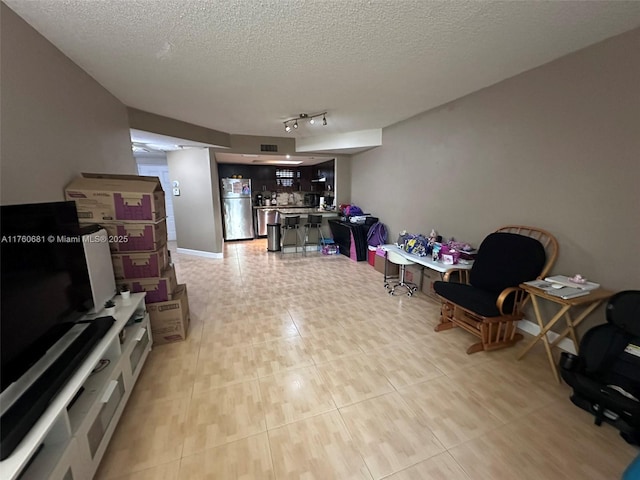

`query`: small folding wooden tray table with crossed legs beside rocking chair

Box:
[518,283,614,383]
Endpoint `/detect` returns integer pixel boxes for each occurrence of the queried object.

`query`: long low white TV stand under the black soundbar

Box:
[0,293,153,480]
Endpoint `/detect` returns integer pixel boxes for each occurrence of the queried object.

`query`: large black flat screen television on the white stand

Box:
[0,202,93,391]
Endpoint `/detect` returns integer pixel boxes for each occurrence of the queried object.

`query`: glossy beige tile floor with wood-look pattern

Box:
[97,240,638,480]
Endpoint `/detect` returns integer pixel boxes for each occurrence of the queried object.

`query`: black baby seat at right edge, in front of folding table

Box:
[560,290,640,445]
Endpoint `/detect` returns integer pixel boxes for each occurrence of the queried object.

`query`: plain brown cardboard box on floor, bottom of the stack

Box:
[147,284,191,345]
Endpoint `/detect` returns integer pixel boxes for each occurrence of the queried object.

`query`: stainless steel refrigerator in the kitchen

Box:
[222,178,254,240]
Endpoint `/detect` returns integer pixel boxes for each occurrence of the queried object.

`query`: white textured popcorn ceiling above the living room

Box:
[4,0,640,142]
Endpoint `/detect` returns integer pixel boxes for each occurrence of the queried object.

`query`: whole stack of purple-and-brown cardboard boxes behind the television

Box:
[65,173,189,344]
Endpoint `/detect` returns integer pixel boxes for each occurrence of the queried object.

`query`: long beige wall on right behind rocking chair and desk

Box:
[351,29,640,330]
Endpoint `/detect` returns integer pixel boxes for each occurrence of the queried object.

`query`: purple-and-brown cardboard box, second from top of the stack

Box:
[97,220,167,252]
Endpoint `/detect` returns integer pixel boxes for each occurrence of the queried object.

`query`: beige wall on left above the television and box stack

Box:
[0,3,136,204]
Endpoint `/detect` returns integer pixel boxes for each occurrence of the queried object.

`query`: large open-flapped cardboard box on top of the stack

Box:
[65,173,167,224]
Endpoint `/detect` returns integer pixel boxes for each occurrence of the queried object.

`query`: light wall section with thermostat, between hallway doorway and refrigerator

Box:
[167,148,222,253]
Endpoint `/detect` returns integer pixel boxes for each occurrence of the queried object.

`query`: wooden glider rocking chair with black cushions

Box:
[433,225,558,353]
